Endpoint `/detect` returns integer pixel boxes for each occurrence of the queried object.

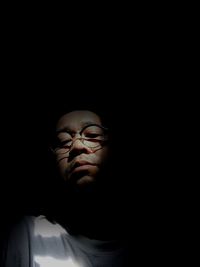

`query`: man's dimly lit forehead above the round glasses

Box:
[56,110,101,131]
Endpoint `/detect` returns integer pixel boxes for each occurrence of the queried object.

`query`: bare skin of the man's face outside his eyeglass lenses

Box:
[56,110,109,187]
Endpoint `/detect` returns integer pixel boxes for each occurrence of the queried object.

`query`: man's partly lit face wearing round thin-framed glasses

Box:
[53,110,108,186]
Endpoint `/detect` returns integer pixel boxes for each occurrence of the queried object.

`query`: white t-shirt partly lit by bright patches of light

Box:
[2,216,126,267]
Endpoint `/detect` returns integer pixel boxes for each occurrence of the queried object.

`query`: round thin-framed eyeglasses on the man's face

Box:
[51,124,108,157]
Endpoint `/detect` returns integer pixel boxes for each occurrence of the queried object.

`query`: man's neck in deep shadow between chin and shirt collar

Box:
[51,186,123,240]
